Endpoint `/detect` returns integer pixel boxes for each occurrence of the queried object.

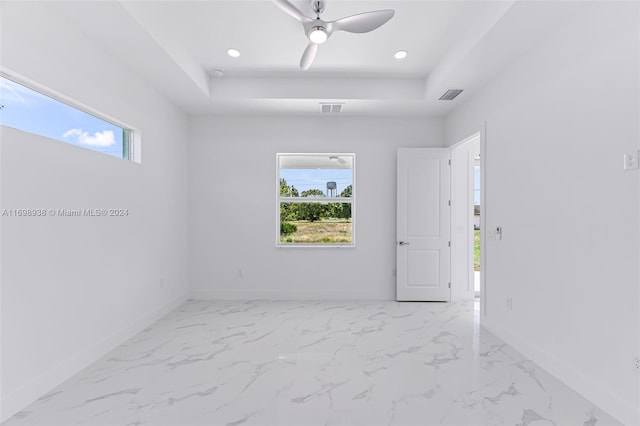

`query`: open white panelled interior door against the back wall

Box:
[396,148,451,302]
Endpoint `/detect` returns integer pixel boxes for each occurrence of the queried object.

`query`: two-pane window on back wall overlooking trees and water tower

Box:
[276,153,355,247]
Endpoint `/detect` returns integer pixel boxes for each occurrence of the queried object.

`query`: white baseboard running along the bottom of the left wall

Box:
[0,295,187,423]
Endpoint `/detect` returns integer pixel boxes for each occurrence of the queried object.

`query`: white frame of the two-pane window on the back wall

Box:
[275,152,356,249]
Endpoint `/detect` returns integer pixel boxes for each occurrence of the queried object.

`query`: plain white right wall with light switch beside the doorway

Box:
[446,2,640,424]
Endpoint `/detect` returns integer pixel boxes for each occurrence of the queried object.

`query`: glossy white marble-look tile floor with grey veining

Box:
[5,301,618,426]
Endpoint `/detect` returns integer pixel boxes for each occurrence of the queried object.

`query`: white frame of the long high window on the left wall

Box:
[0,69,142,163]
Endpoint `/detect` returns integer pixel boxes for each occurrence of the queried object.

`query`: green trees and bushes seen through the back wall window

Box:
[280,179,353,234]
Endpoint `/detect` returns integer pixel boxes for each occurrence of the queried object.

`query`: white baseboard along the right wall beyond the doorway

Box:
[480,317,640,426]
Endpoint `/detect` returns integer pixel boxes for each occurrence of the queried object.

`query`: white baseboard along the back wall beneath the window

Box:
[189,288,395,300]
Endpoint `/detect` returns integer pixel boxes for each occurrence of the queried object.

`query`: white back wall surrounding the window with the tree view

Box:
[189,116,444,299]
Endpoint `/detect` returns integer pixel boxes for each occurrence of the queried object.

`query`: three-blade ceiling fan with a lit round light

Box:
[272,0,395,70]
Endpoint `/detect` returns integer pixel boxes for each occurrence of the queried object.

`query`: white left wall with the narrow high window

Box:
[0,2,188,419]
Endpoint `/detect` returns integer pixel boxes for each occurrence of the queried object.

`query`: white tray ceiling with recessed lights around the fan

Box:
[45,0,581,116]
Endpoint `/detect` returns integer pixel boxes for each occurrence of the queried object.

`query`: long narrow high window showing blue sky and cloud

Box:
[0,76,132,160]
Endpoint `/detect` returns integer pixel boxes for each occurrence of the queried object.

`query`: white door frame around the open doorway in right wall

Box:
[449,125,490,316]
